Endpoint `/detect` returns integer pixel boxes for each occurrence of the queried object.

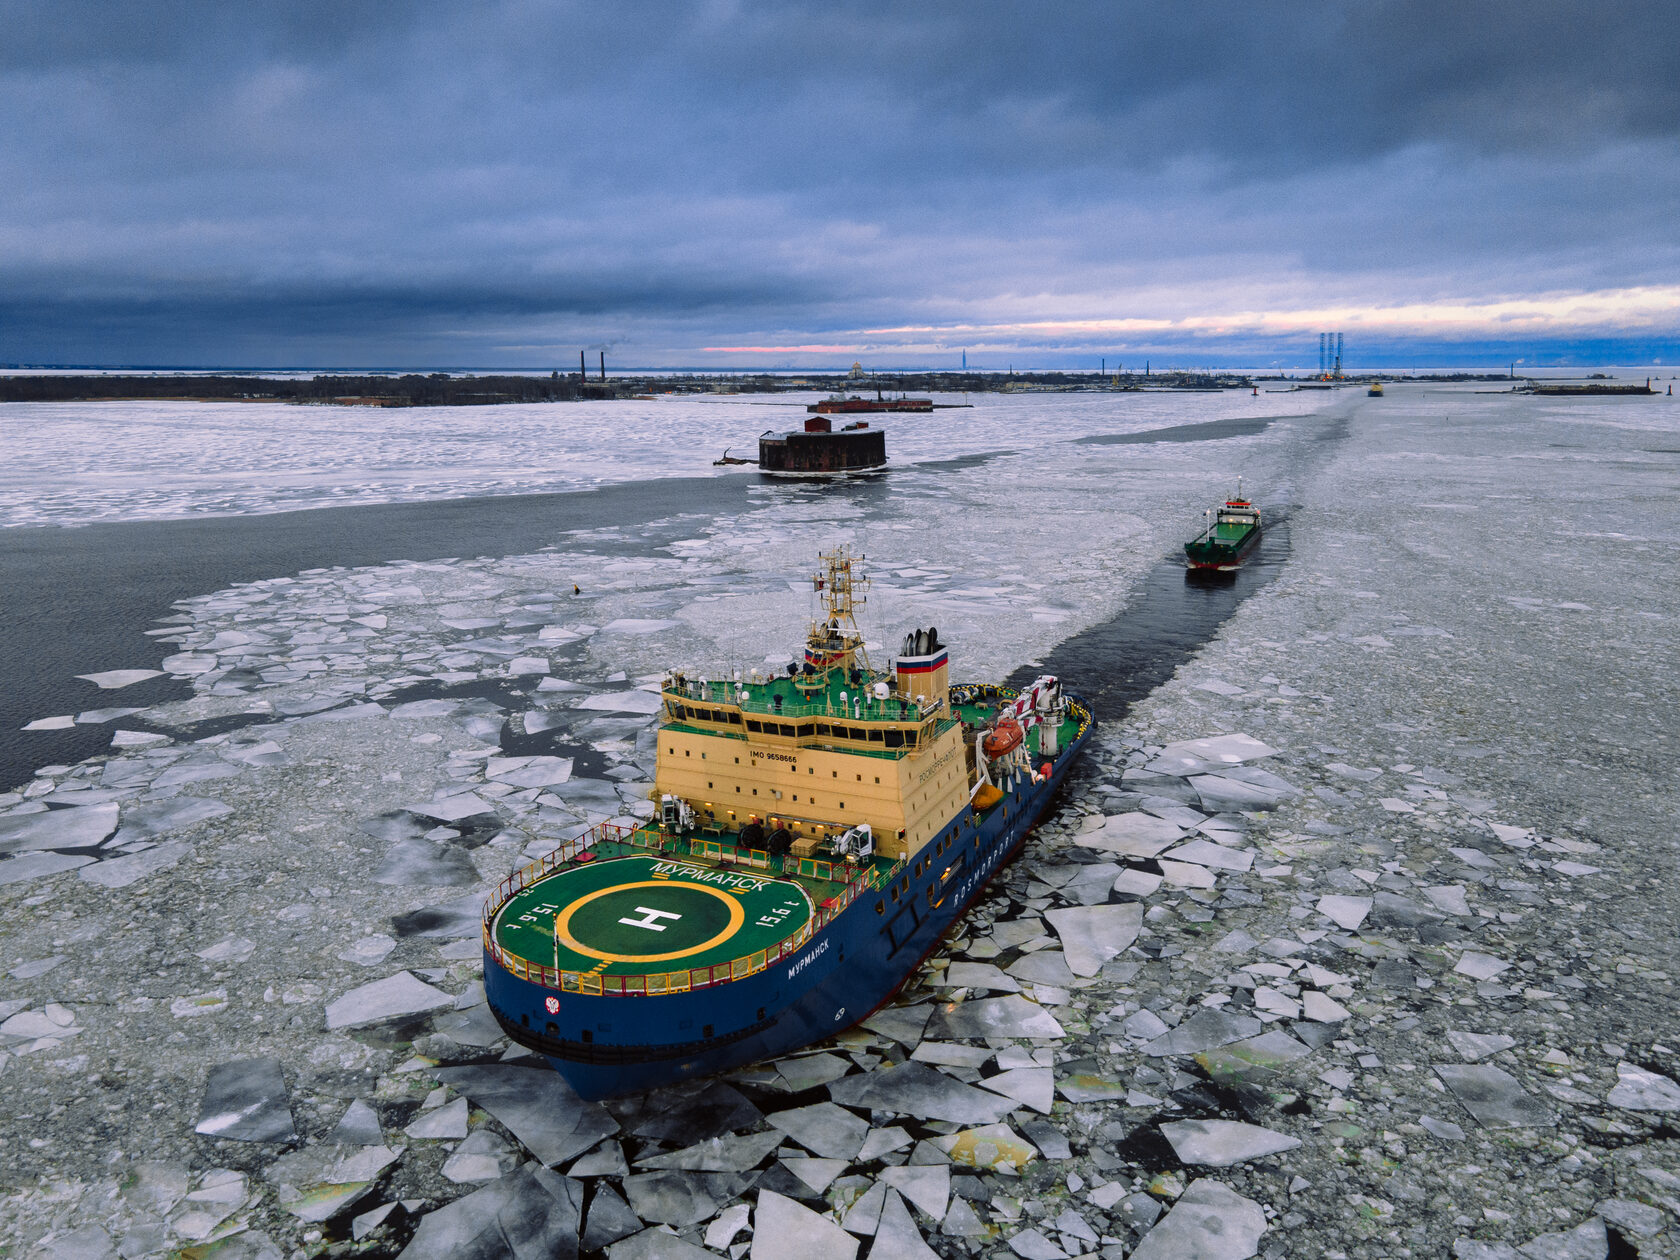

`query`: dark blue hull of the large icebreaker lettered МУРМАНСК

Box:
[484,705,1090,1099]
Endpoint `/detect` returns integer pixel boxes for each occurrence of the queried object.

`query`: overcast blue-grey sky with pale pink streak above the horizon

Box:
[0,0,1680,368]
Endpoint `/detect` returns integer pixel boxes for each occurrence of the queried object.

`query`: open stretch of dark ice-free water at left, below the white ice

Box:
[0,475,758,790]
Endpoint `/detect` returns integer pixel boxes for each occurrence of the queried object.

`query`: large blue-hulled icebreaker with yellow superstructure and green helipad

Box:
[482,548,1092,1099]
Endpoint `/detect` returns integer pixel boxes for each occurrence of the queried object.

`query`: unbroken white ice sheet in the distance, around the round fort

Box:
[0,393,1314,526]
